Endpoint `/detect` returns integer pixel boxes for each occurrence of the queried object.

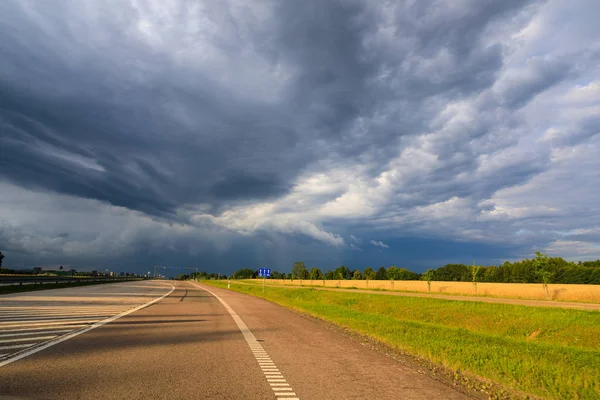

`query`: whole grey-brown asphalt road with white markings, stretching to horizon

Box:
[0,281,467,400]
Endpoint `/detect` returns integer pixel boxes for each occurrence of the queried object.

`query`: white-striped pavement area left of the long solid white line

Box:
[0,281,172,366]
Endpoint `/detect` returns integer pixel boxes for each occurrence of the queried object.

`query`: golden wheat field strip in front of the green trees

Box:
[254,279,600,303]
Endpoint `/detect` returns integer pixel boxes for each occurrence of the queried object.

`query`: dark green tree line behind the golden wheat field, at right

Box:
[230,252,600,285]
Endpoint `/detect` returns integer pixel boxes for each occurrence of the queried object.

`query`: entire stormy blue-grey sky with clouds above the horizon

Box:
[0,0,600,273]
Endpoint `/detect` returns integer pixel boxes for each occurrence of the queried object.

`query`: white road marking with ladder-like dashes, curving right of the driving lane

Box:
[192,283,300,400]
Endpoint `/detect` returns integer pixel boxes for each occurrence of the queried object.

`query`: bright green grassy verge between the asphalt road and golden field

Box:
[206,281,600,399]
